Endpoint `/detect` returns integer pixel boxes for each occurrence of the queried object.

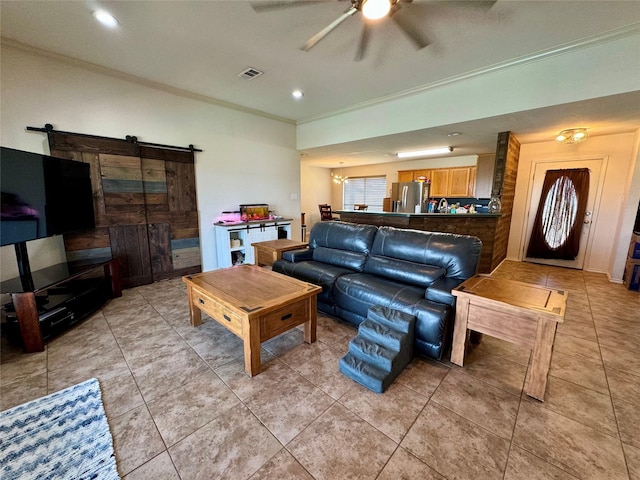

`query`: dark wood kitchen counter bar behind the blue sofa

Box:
[334,210,507,273]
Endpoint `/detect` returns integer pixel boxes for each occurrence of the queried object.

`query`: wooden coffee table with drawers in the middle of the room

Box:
[183,265,322,377]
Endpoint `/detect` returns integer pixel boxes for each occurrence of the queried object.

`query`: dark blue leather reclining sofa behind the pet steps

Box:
[273,221,482,360]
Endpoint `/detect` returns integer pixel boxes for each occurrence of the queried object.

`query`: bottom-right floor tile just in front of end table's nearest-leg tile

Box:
[513,402,627,480]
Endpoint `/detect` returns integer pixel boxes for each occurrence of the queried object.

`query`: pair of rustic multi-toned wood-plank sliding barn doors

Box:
[49,132,201,288]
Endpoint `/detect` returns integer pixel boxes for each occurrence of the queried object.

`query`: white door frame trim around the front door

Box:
[518,155,609,270]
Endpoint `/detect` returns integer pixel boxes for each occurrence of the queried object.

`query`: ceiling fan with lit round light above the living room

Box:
[251,0,429,61]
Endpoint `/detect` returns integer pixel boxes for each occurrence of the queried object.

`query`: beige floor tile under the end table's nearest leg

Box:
[523,375,618,438]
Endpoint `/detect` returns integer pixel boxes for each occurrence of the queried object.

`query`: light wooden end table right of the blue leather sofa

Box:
[451,275,567,401]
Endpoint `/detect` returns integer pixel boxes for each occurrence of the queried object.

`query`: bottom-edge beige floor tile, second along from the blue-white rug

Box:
[169,406,282,480]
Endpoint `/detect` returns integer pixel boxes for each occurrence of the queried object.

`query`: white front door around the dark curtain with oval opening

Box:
[522,159,603,270]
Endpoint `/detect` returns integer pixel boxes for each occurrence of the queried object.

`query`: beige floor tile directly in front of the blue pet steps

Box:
[340,382,428,443]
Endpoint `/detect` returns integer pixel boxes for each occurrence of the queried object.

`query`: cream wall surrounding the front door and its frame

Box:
[507,132,640,282]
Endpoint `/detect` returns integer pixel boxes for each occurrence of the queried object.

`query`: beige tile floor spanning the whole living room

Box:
[0,262,640,480]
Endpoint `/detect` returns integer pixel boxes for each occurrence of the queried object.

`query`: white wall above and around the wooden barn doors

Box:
[0,45,300,278]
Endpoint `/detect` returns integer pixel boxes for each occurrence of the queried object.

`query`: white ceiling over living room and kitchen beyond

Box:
[0,0,640,166]
